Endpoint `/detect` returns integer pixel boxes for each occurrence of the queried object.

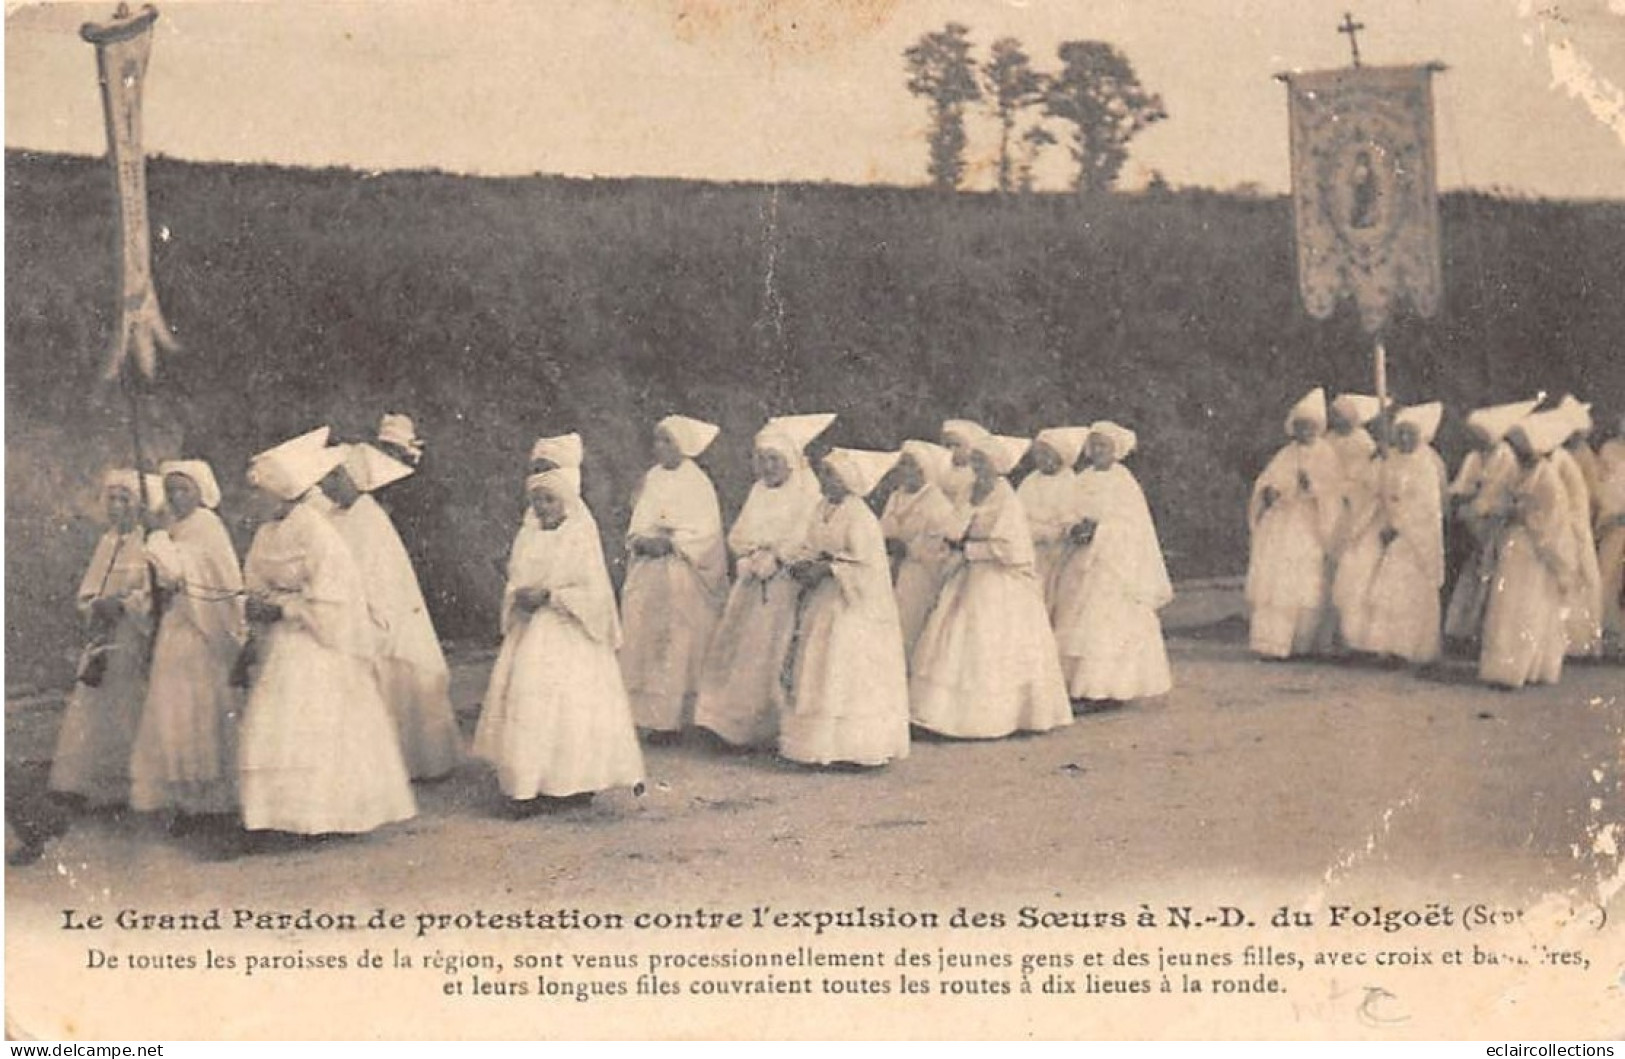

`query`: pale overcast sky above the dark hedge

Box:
[5,0,1625,198]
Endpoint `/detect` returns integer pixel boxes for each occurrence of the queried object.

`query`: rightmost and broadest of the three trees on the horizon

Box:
[1045,41,1168,195]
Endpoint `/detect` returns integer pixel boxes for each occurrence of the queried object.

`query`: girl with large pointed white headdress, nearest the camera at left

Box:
[237,429,418,835]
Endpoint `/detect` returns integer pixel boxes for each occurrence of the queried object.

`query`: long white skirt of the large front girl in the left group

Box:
[237,622,418,835]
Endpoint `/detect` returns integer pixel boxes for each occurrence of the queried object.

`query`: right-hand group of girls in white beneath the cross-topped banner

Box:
[1246,390,1625,689]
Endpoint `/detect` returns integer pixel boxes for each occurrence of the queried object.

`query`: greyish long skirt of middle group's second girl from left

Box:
[694,575,800,747]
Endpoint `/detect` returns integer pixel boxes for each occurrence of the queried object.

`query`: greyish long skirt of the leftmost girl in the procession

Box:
[49,622,146,806]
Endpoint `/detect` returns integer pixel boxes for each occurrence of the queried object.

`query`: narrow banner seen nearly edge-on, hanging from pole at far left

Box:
[80,5,176,378]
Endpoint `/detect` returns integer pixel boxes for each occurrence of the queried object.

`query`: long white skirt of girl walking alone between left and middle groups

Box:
[475,607,644,801]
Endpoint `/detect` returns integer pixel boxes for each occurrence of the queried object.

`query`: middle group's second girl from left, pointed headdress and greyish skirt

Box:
[694,414,835,747]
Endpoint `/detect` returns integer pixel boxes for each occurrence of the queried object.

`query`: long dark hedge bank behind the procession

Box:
[5,153,1625,687]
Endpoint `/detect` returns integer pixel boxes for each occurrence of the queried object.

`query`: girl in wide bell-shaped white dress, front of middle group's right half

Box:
[908,434,1073,739]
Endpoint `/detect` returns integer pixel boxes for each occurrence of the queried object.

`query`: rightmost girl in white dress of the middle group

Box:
[1051,421,1173,702]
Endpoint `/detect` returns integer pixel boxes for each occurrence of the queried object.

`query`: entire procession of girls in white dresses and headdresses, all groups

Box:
[41,390,1625,835]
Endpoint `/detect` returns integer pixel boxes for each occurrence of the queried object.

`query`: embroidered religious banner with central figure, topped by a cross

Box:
[1284,67,1443,333]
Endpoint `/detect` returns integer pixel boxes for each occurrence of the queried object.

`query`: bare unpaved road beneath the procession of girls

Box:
[7,625,1625,1039]
